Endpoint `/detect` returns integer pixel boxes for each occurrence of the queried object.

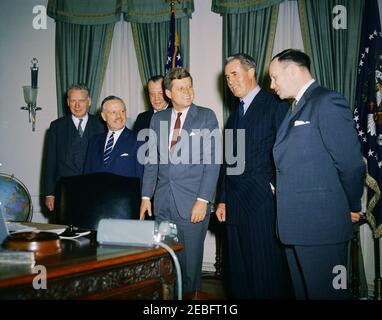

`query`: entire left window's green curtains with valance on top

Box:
[47,0,194,116]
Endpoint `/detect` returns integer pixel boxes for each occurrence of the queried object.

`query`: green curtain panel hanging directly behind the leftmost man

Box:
[56,21,114,116]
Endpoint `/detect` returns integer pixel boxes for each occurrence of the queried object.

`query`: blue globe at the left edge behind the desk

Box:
[0,173,32,221]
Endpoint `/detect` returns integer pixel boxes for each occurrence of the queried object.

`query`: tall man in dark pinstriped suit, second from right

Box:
[216,54,293,299]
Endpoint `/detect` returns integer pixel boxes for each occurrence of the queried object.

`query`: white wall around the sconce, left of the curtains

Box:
[0,0,57,221]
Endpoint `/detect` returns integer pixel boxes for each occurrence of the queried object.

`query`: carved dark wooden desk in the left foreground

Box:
[0,237,182,299]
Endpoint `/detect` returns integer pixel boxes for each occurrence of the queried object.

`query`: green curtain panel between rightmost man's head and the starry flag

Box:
[298,0,364,108]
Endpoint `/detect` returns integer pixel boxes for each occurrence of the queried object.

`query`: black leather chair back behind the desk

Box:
[55,173,141,230]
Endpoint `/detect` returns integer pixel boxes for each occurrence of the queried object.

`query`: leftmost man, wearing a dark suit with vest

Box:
[44,84,105,211]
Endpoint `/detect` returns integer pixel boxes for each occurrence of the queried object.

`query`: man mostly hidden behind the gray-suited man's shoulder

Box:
[134,75,168,134]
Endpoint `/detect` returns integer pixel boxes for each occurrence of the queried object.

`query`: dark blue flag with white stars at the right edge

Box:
[354,0,382,238]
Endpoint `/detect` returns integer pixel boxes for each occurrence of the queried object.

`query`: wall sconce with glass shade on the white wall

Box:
[21,58,42,131]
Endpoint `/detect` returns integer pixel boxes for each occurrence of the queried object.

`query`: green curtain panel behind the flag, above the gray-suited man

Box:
[131,17,190,86]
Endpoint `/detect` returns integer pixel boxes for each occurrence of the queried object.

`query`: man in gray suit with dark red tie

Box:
[140,68,220,294]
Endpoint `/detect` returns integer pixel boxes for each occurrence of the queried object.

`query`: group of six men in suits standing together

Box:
[46,49,365,299]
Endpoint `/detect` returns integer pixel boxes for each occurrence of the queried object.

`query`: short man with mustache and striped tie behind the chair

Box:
[84,96,143,178]
